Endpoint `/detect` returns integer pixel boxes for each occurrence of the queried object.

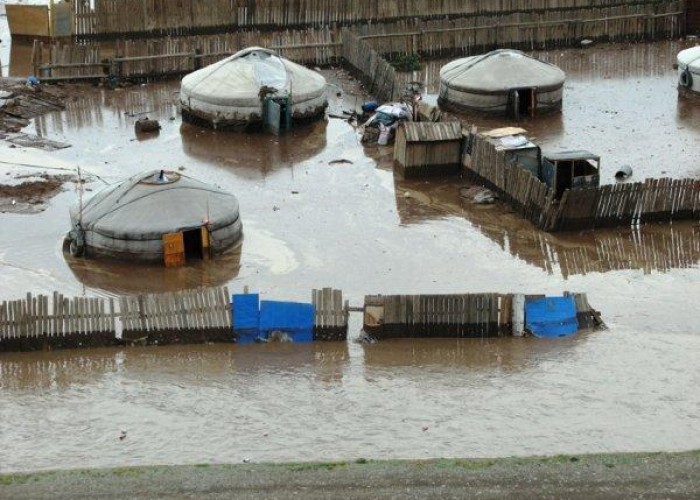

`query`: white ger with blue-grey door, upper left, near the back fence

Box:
[180,47,328,133]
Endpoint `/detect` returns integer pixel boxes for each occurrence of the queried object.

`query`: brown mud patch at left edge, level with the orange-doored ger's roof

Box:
[0,174,72,214]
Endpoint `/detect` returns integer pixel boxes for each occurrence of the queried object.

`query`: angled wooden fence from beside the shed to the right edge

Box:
[464,134,700,232]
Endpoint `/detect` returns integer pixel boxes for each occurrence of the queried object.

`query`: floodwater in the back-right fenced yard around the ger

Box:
[414,41,700,183]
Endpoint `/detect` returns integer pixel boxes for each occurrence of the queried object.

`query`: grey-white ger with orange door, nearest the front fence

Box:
[66,170,243,267]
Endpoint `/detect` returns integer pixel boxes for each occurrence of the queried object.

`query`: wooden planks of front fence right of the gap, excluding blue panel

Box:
[363,293,602,340]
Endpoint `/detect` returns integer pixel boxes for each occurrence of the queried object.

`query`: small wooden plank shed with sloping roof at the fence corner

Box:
[394,122,464,178]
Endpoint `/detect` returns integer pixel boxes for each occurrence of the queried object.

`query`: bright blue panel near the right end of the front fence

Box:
[525,296,578,338]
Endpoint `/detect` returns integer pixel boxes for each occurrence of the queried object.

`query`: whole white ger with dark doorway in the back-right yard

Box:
[438,49,566,118]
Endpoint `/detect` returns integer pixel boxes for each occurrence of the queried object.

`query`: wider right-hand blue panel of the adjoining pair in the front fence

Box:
[260,300,314,342]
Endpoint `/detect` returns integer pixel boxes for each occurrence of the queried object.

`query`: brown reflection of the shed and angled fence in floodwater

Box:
[395,178,700,278]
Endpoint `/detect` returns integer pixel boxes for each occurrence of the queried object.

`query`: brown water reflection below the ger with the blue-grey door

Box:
[180,120,326,179]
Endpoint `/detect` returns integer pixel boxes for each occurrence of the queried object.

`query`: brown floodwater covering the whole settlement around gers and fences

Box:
[0,42,700,472]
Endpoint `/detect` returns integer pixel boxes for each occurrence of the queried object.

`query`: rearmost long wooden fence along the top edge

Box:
[67,0,685,39]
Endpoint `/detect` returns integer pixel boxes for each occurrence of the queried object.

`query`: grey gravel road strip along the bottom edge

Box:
[0,451,700,500]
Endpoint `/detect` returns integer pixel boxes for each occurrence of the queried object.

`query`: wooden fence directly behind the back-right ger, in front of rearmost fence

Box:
[352,2,684,57]
